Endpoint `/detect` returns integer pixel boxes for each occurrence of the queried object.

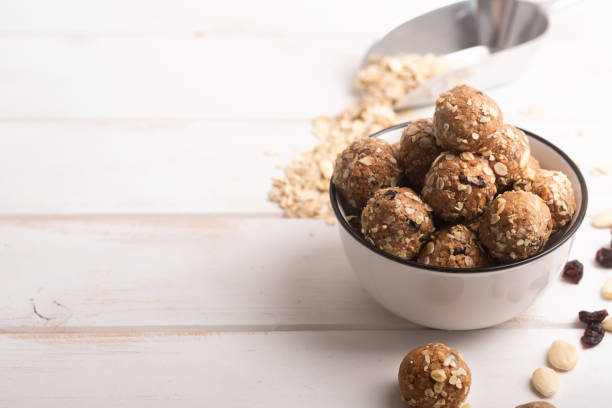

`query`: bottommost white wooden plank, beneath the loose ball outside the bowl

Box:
[0,329,612,408]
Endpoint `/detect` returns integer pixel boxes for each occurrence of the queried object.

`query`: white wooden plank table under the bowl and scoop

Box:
[0,0,612,408]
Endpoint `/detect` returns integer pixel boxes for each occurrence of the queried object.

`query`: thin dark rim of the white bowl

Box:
[329,122,589,274]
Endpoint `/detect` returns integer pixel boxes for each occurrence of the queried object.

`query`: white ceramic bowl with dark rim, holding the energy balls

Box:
[330,123,587,330]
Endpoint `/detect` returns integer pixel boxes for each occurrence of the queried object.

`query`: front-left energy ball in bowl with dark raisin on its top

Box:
[361,187,434,259]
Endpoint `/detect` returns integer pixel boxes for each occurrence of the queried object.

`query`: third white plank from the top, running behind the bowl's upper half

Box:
[0,119,612,215]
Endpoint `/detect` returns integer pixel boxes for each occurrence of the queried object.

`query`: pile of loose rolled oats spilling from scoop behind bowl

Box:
[268,54,447,225]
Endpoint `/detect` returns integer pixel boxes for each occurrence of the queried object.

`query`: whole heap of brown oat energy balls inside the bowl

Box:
[332,85,576,268]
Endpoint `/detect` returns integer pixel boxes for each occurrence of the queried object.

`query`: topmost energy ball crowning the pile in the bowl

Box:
[433,85,504,152]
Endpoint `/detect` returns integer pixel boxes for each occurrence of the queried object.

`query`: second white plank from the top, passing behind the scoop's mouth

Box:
[0,24,612,121]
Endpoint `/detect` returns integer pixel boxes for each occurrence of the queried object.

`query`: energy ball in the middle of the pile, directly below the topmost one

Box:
[422,152,497,223]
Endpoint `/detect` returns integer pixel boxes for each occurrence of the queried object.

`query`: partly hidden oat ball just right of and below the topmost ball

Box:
[478,124,531,191]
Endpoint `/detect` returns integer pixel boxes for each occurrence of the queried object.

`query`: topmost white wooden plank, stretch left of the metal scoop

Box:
[0,0,451,36]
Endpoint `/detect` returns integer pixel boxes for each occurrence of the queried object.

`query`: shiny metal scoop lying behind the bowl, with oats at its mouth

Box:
[364,0,576,109]
